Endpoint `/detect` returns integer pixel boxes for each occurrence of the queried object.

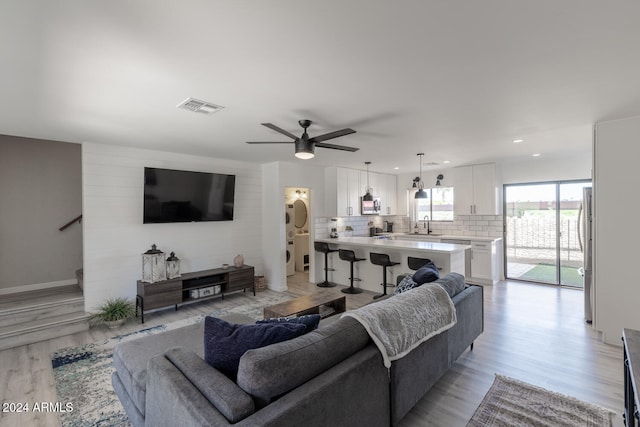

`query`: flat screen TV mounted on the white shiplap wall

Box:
[143,168,236,224]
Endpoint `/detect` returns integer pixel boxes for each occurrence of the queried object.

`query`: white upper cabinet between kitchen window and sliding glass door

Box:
[453,163,500,215]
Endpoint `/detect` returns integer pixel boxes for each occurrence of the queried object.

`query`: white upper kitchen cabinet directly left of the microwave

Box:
[325,167,366,216]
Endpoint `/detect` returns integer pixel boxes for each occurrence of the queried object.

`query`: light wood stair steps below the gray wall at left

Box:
[0,285,89,350]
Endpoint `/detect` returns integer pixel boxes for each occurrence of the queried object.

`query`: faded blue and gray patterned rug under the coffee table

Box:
[51,291,293,427]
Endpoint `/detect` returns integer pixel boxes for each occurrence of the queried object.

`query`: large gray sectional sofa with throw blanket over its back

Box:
[112,286,484,427]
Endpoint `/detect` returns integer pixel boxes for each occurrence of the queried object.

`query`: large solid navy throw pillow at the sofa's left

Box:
[204,316,307,380]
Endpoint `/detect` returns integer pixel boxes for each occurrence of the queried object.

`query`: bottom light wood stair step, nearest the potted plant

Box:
[0,311,89,350]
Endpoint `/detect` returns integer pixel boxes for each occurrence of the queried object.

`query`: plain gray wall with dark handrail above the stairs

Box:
[0,135,82,291]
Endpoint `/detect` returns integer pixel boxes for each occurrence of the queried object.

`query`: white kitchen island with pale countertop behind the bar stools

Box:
[314,237,471,293]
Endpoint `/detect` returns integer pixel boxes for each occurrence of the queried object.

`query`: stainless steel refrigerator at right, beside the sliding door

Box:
[578,187,594,323]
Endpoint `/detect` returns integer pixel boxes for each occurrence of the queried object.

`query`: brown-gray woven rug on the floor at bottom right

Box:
[467,375,613,427]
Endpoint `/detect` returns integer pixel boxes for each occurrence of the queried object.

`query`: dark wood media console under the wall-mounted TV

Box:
[136,265,256,323]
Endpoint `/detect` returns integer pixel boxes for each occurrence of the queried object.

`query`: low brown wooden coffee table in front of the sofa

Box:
[264,292,347,319]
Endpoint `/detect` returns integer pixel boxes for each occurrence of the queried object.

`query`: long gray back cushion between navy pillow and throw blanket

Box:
[237,317,370,405]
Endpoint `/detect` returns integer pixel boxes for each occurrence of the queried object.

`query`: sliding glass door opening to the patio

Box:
[504,181,591,287]
